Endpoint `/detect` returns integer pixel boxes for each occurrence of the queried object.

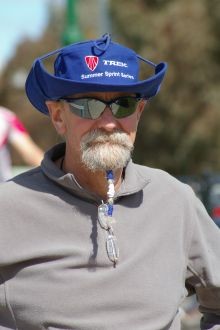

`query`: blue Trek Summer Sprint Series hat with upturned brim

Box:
[25,34,167,114]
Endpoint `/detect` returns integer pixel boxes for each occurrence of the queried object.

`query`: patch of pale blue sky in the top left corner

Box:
[0,0,65,71]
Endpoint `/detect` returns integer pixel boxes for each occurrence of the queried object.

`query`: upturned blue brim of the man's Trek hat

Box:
[25,59,167,115]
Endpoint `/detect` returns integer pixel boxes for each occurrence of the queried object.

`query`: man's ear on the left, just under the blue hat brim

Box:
[46,101,66,135]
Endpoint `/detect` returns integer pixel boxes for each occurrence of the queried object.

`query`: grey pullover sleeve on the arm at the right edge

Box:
[186,198,220,330]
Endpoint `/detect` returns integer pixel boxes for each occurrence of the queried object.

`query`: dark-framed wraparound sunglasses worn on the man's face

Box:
[61,96,142,119]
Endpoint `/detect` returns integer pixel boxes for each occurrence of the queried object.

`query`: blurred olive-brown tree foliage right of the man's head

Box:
[111,0,220,174]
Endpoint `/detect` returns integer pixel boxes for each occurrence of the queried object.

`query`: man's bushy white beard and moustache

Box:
[81,129,133,172]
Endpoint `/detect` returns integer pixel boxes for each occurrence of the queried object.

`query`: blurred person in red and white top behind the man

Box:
[0,106,43,182]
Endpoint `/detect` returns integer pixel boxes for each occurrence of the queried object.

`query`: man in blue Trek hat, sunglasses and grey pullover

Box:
[0,34,220,330]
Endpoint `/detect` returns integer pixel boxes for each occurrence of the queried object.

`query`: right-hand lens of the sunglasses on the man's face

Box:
[112,97,138,118]
